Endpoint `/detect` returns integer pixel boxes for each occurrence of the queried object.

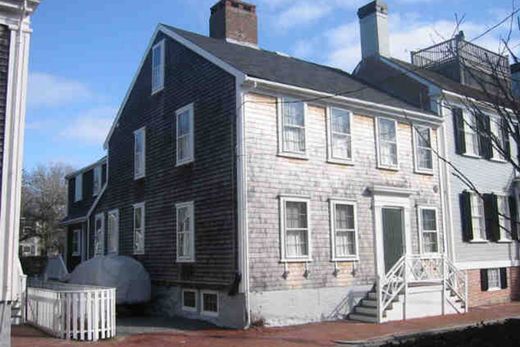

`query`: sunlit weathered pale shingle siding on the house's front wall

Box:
[246,94,443,292]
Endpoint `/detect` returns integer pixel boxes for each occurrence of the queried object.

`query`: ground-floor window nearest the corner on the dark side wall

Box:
[176,202,195,263]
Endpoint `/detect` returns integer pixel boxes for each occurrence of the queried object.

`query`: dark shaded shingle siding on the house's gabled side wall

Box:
[91,34,237,286]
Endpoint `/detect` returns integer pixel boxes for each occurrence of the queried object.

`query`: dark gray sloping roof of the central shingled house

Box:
[164,25,425,113]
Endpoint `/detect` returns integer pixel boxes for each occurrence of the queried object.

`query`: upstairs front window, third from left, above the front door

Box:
[377,118,398,169]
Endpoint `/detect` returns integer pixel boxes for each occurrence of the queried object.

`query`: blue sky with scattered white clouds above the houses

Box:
[24,0,520,168]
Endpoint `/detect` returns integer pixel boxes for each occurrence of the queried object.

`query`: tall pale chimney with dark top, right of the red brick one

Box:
[358,0,390,59]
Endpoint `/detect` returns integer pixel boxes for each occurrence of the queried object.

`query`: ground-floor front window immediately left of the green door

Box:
[330,200,358,260]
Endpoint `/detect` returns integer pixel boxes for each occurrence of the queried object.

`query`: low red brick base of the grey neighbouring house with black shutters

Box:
[467,267,520,307]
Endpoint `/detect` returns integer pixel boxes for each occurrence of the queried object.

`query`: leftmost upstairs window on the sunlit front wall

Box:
[280,98,306,155]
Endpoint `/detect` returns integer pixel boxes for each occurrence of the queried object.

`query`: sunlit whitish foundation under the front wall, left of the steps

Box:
[250,286,372,326]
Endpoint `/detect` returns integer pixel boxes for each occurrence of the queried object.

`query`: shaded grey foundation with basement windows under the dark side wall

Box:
[149,286,246,329]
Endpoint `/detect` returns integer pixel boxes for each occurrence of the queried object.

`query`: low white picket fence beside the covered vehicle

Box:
[26,282,116,341]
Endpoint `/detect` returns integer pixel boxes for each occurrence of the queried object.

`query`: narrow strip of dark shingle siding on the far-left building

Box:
[0,25,11,208]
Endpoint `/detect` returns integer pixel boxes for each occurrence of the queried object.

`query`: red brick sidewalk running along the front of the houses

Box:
[12,302,520,347]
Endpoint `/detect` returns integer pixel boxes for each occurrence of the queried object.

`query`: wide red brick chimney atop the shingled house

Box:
[209,0,258,46]
